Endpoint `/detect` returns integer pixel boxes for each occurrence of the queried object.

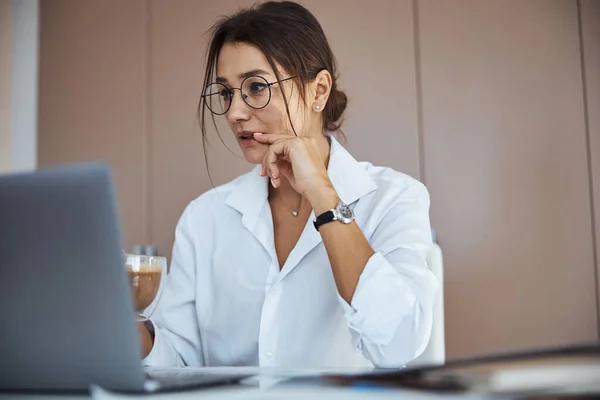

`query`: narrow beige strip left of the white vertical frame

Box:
[0,0,12,174]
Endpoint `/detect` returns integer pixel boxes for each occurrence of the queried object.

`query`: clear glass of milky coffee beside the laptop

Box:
[125,254,167,321]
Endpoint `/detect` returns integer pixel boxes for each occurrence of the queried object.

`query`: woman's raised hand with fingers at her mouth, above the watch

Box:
[254,133,333,201]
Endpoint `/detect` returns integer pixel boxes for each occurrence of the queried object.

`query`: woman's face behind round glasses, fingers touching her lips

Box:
[217,43,322,164]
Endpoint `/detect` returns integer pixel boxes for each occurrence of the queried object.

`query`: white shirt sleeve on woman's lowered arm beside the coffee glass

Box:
[143,205,204,367]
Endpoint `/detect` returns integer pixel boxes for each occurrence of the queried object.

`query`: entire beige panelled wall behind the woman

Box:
[39,0,600,356]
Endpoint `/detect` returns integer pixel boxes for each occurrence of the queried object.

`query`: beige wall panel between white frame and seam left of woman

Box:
[38,0,149,246]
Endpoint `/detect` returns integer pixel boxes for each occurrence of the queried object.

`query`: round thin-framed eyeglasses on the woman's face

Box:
[202,76,296,115]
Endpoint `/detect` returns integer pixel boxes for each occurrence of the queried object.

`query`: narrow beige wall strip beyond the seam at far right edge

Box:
[580,0,600,330]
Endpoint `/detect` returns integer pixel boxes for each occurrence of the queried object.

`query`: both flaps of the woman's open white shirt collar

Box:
[226,135,377,226]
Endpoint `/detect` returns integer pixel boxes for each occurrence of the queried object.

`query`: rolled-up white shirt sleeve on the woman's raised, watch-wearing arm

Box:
[338,181,438,367]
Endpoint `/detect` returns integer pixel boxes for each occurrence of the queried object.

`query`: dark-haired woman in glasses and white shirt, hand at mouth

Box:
[140,2,437,368]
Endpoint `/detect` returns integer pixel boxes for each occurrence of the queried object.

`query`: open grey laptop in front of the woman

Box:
[0,164,246,393]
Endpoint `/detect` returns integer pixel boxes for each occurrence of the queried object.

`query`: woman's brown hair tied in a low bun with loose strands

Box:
[198,1,347,155]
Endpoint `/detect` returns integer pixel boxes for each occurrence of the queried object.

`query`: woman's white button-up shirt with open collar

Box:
[144,138,437,368]
